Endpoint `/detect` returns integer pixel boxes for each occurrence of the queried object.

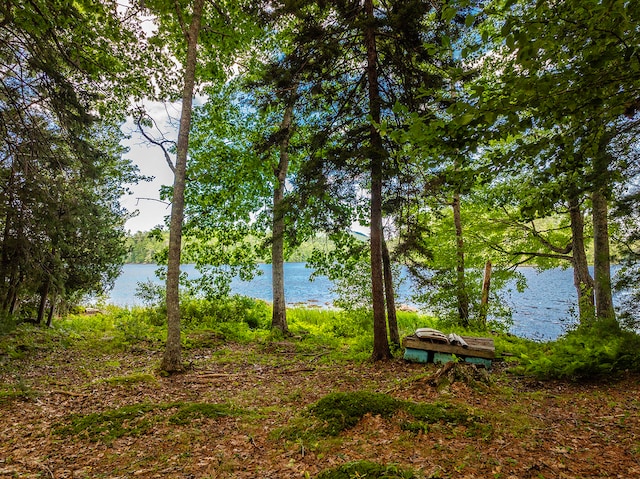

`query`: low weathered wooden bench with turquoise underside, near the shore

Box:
[402,335,496,369]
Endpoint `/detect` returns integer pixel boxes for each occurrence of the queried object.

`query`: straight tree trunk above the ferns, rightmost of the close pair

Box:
[591,190,616,320]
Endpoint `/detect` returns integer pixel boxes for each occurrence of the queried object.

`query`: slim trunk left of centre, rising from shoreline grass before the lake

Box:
[271,101,293,333]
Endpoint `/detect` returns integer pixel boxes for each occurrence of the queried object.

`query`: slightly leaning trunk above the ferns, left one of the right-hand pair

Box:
[569,198,595,321]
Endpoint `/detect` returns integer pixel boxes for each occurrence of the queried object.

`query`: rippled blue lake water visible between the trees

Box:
[109,263,608,340]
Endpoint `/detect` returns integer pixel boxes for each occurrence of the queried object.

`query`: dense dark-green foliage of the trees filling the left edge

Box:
[0,0,145,320]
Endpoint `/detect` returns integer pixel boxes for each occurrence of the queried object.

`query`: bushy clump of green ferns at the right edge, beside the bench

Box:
[516,320,640,379]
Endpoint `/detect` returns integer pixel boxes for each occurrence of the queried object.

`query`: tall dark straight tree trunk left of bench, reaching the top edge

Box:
[364,0,391,361]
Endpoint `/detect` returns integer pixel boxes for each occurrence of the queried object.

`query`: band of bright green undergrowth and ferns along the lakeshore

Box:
[0,296,640,379]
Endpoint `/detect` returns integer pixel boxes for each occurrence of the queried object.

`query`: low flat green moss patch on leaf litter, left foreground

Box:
[53,402,238,444]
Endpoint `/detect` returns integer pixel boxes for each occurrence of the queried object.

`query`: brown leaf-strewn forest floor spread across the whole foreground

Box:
[0,330,640,479]
